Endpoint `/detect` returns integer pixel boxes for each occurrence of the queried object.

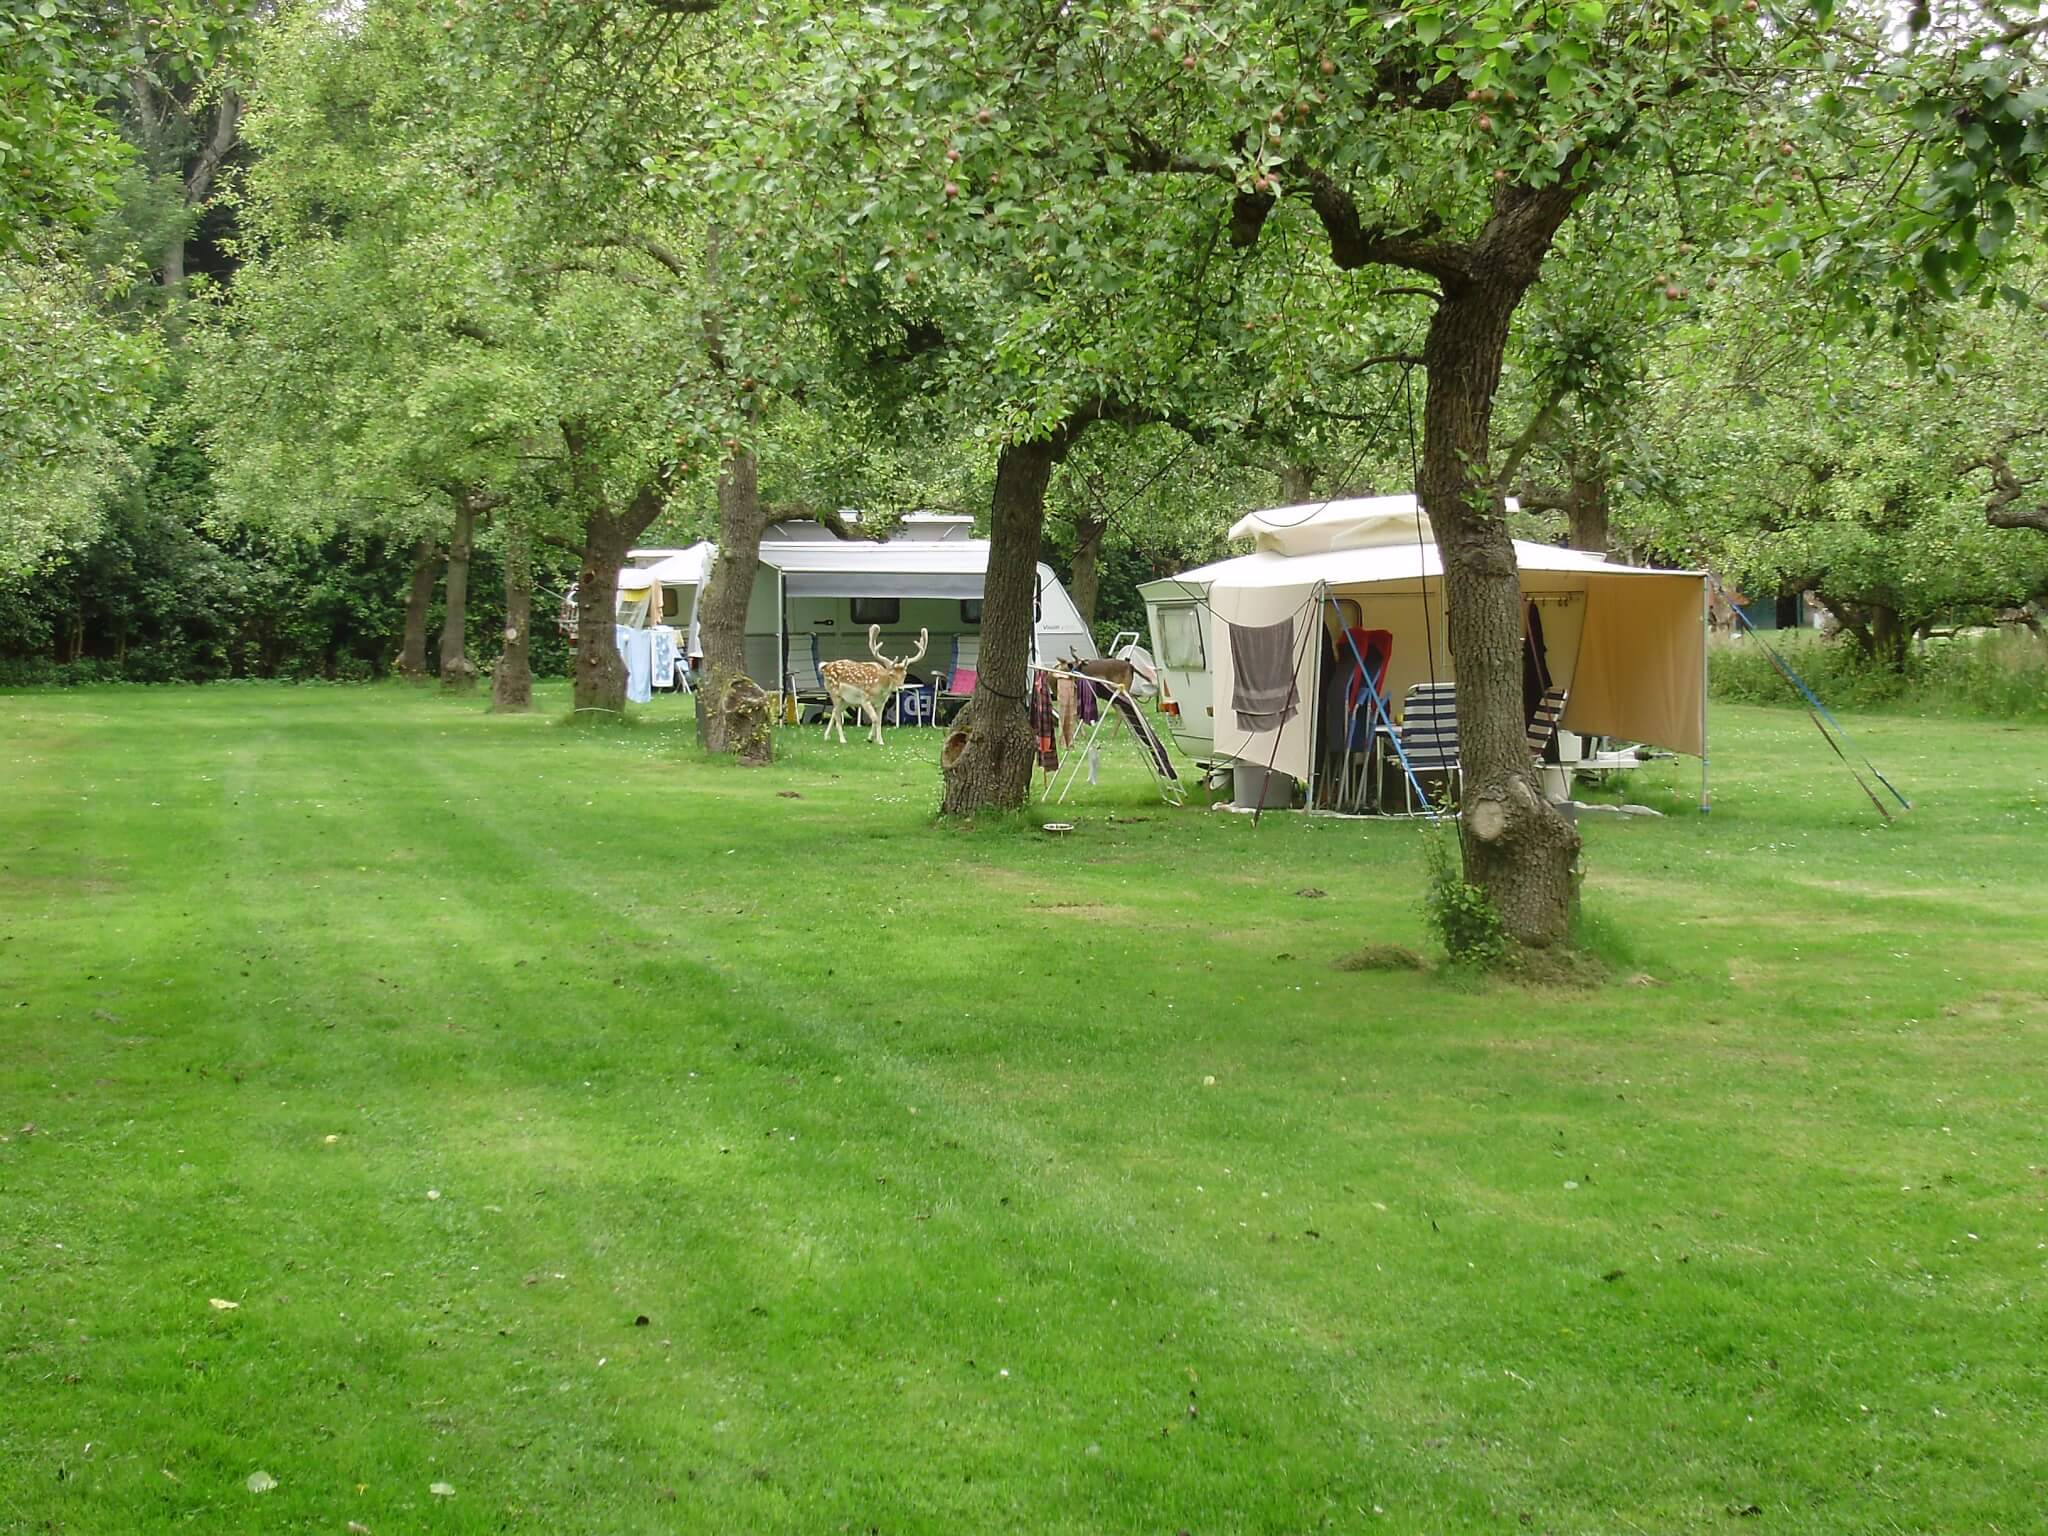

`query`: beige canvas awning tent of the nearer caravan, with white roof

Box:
[1176,496,1706,778]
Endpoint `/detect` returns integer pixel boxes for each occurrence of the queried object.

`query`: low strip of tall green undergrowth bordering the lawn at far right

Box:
[1706,631,2048,721]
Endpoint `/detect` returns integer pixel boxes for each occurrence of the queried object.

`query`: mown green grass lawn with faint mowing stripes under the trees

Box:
[12,686,2048,1536]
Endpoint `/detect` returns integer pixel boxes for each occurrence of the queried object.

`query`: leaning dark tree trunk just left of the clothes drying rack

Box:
[938,434,1065,815]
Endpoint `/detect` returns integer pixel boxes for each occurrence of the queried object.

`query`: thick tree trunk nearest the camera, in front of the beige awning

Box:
[1417,276,1579,948]
